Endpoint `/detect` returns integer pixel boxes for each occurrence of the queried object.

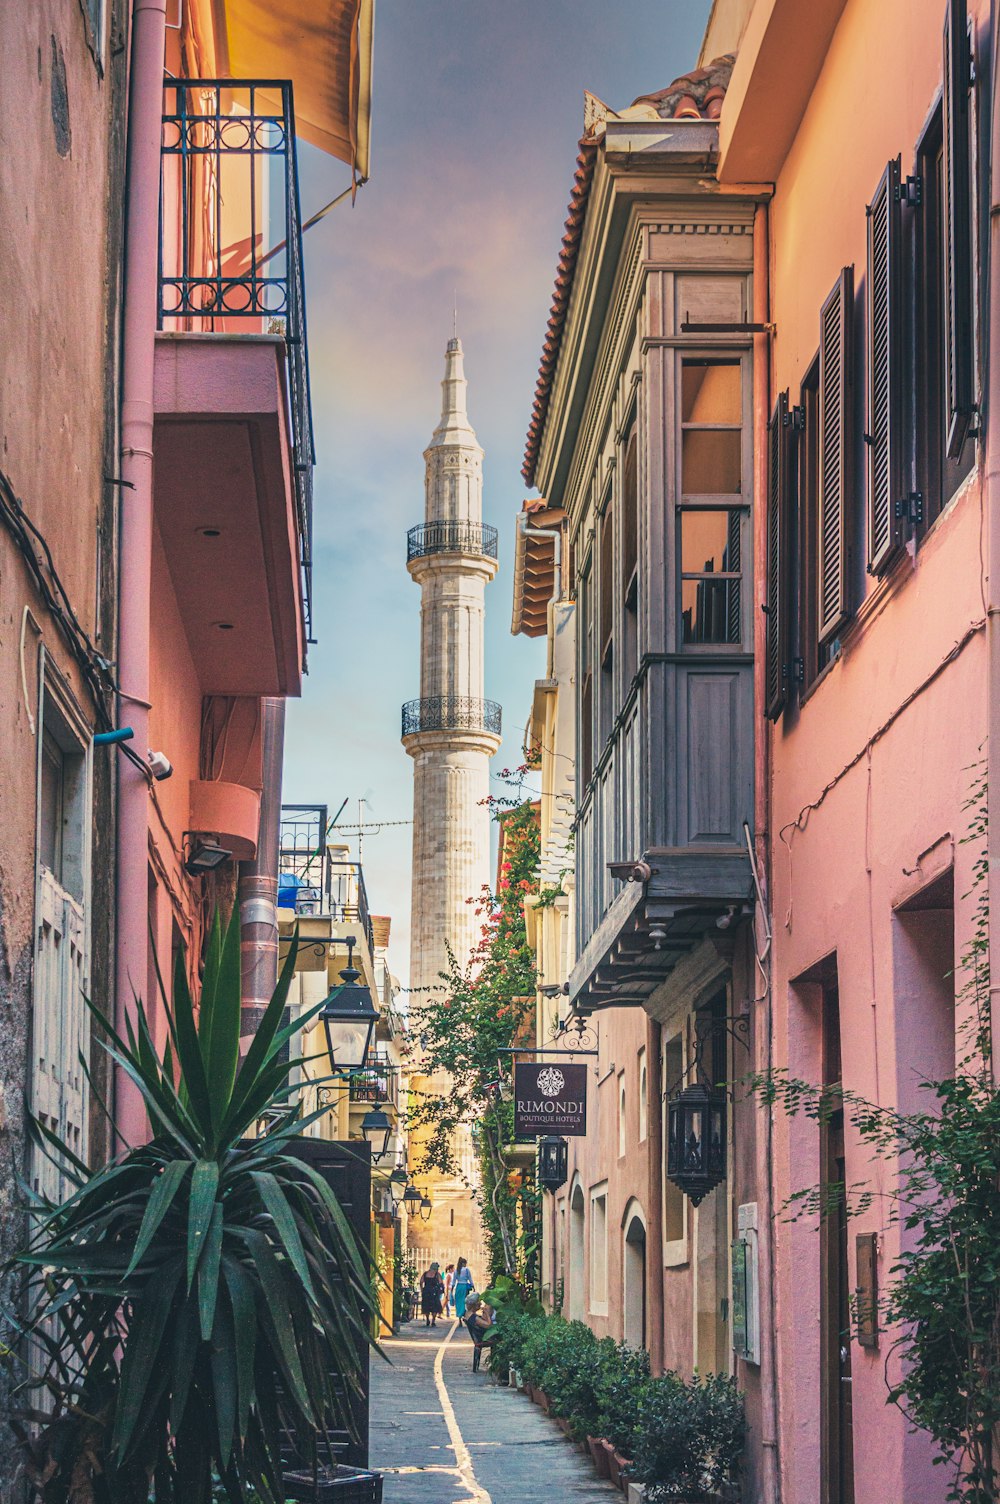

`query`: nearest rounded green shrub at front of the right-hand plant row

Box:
[632,1373,746,1504]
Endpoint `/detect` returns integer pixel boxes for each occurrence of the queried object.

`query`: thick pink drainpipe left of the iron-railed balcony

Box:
[114,0,167,1143]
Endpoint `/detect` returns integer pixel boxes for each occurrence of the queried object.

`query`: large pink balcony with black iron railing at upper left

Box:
[153,80,314,695]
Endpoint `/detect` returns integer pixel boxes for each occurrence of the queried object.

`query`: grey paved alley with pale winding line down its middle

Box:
[371,1321,623,1504]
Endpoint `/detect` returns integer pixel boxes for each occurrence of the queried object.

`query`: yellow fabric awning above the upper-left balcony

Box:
[217,0,374,177]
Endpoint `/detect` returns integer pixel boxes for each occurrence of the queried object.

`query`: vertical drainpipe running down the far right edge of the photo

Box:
[983,0,1000,1083]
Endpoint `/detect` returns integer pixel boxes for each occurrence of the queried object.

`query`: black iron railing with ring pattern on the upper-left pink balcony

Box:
[158,78,316,641]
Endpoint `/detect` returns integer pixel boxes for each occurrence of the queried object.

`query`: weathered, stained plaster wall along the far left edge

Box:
[0,0,128,1479]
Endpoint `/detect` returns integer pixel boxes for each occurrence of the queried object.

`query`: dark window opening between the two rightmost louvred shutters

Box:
[914,110,974,528]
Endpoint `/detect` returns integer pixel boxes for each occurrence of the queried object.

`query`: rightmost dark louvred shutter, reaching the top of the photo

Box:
[943,0,974,459]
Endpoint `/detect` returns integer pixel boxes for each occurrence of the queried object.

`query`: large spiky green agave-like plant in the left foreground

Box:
[8,916,373,1504]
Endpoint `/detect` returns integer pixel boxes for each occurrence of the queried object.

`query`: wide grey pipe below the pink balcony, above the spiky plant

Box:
[239,698,284,1050]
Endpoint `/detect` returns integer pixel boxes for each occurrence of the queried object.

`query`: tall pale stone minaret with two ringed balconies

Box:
[403,337,501,1277]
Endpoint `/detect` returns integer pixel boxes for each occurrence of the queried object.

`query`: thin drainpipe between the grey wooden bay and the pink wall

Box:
[752,203,782,1504]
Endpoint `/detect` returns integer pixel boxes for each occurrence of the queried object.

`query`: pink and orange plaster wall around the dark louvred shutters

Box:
[770,0,986,1504]
